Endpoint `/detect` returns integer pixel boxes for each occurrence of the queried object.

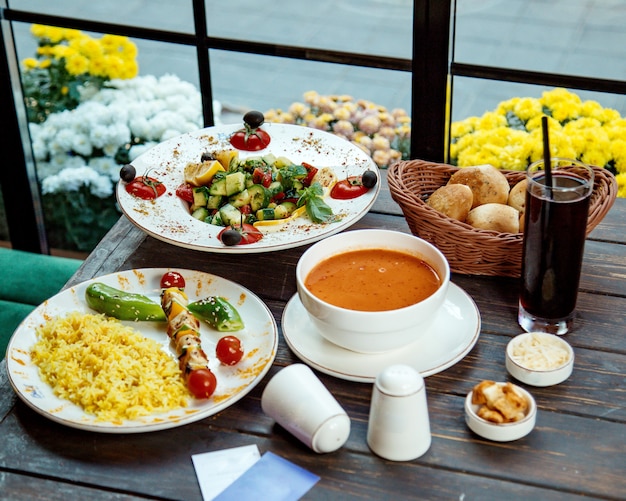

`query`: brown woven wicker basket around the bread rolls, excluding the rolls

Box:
[388,160,617,277]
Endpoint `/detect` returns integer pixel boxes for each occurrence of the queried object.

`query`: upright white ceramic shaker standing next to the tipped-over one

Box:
[367,365,431,461]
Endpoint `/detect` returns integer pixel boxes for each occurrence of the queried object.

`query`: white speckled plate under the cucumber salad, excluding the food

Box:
[116,123,380,253]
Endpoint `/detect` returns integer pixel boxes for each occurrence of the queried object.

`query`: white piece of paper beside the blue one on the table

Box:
[191,445,261,501]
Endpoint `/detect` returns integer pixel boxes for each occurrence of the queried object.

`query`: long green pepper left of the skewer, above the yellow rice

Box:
[85,282,165,322]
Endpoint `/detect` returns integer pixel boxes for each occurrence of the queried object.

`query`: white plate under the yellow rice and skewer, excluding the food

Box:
[6,268,278,433]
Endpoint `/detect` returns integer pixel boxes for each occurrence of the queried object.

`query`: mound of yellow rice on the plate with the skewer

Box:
[31,312,189,422]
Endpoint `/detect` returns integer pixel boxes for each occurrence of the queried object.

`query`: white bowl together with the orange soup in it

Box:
[296,230,450,353]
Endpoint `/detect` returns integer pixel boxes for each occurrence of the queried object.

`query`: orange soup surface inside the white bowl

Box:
[304,249,441,311]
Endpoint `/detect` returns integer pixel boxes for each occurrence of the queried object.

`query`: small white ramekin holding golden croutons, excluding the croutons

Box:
[465,383,537,442]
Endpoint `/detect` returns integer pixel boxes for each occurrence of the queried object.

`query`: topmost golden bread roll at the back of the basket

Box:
[448,165,510,209]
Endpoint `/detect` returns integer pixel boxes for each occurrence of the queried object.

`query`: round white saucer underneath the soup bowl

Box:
[282,283,480,383]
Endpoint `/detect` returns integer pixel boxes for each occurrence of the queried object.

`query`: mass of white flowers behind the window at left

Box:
[30,75,205,198]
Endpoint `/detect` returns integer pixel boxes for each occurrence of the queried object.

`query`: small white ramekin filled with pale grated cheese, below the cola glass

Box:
[505,332,574,386]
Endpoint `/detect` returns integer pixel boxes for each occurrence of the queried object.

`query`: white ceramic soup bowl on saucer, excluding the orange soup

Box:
[296,230,450,353]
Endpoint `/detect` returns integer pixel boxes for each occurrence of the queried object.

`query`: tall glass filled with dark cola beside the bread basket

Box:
[518,157,594,335]
